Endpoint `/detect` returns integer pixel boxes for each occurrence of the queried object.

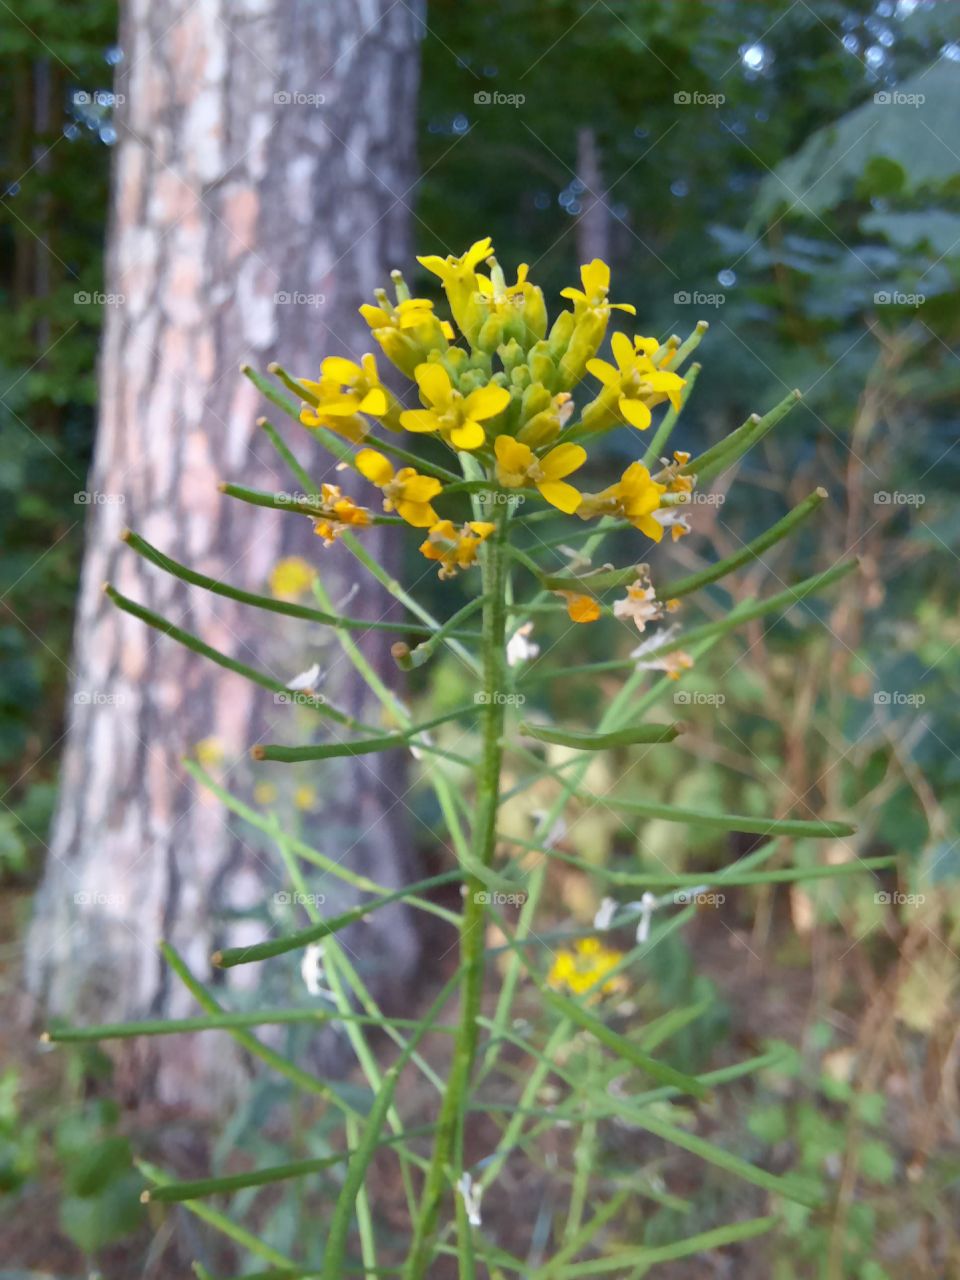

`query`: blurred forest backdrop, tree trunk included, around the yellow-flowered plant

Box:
[0,0,960,1280]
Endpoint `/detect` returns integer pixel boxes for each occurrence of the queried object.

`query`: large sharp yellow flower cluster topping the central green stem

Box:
[291,237,692,586]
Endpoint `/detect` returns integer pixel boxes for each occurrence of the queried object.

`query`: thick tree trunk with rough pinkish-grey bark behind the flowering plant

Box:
[27,0,419,1106]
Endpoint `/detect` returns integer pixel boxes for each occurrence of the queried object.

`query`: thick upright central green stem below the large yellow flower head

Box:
[403,508,509,1280]
